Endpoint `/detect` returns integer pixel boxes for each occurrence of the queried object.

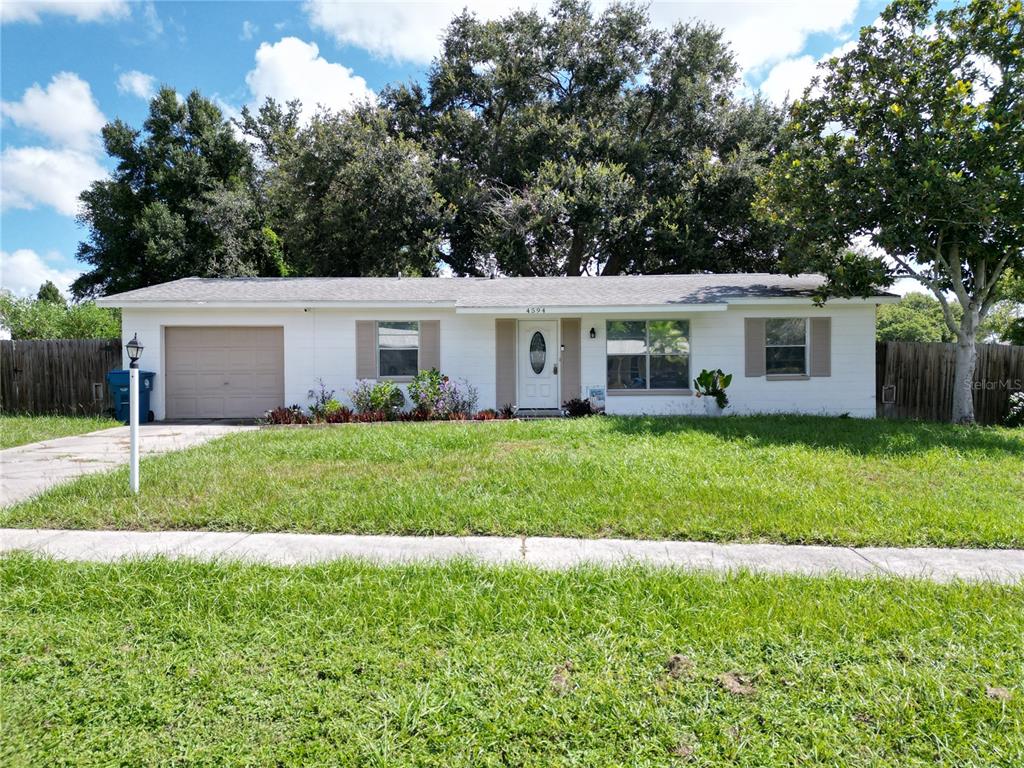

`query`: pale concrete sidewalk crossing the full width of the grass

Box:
[0,528,1024,584]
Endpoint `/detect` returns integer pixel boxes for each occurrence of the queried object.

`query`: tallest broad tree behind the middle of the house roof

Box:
[382,0,783,274]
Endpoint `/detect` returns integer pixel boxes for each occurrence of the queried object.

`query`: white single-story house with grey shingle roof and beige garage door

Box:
[98,274,895,419]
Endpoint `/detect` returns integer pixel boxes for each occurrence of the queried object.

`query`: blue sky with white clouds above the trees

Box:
[0,0,897,294]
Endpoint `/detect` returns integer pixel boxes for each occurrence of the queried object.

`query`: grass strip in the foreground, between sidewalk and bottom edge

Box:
[0,557,1024,768]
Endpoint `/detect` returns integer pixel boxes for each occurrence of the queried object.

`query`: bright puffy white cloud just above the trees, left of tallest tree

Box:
[246,37,374,115]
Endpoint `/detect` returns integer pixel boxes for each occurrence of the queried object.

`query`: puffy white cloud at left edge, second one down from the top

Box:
[0,72,106,150]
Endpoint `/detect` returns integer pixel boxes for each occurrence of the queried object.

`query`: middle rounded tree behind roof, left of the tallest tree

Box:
[242,100,443,276]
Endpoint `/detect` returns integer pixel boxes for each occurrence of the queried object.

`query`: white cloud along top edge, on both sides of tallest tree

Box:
[305,0,859,72]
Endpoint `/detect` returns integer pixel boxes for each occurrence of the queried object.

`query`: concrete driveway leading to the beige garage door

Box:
[0,422,257,507]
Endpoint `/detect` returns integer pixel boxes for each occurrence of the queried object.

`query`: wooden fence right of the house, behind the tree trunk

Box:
[874,341,1024,424]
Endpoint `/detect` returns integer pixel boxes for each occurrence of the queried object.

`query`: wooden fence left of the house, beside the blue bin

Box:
[0,339,121,414]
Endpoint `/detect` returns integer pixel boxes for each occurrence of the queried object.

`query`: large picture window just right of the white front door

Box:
[607,321,690,390]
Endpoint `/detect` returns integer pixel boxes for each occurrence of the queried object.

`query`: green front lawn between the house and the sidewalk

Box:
[0,417,1024,547]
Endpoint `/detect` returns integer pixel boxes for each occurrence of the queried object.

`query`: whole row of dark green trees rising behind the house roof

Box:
[74,0,784,296]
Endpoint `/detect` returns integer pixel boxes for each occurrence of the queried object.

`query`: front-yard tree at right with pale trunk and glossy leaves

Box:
[759,0,1024,422]
